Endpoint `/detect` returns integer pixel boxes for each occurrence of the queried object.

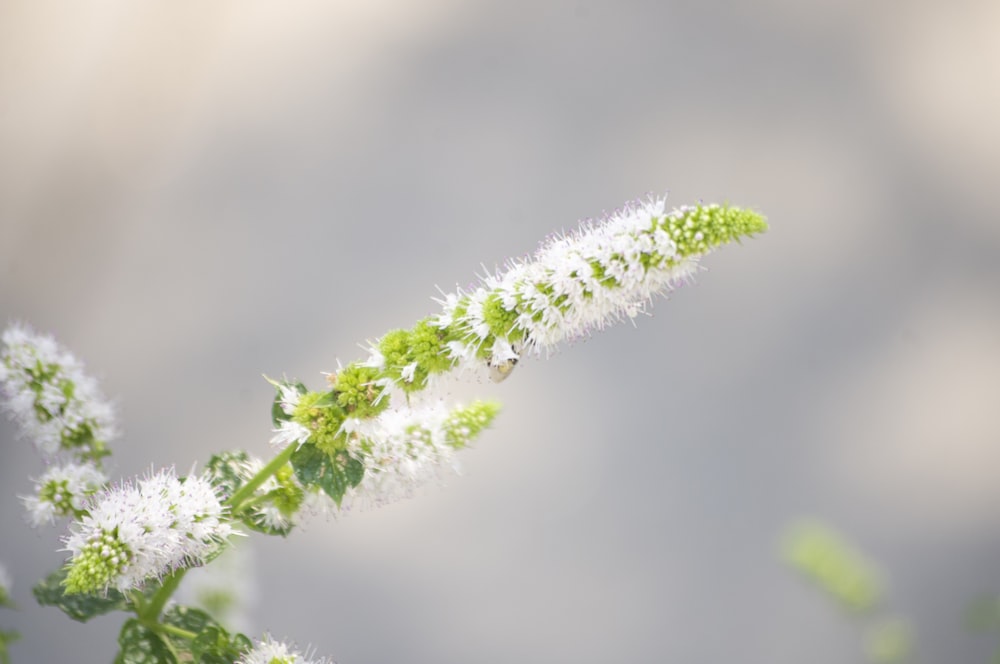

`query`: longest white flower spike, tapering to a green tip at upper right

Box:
[364,197,767,393]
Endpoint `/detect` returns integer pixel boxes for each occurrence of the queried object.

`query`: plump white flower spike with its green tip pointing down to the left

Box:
[65,469,233,593]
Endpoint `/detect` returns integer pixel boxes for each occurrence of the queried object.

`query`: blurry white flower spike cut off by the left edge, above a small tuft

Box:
[0,324,117,461]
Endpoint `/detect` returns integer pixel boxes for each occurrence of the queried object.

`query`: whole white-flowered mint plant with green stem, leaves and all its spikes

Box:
[0,192,768,664]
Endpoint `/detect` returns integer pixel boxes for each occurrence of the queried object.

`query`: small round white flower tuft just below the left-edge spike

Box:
[21,462,108,528]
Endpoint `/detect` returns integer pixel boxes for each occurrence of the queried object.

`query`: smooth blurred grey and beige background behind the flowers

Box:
[0,0,1000,664]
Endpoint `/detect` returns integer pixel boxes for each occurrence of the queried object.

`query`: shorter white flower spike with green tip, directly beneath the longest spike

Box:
[344,401,500,507]
